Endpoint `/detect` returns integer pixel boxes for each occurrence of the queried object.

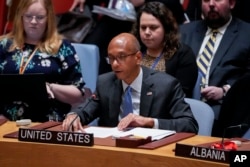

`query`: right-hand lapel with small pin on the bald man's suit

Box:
[140,68,155,116]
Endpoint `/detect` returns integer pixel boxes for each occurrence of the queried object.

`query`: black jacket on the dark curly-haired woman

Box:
[165,44,198,98]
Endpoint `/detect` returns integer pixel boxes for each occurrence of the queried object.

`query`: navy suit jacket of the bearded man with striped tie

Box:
[180,18,250,118]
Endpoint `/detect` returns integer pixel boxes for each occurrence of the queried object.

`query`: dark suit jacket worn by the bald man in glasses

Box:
[74,67,198,133]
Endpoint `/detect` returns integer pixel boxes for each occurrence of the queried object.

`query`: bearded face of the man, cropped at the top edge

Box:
[202,0,235,28]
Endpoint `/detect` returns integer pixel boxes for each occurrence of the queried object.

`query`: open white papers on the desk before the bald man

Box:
[85,127,176,140]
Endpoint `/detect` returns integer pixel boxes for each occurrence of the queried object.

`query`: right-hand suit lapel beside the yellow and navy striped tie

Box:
[210,20,238,76]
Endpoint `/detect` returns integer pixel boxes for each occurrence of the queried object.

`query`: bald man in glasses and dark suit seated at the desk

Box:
[63,33,198,133]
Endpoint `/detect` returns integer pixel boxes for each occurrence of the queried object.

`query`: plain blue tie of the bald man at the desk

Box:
[122,86,133,117]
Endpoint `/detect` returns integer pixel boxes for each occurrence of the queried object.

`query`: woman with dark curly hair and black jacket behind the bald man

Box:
[132,2,198,97]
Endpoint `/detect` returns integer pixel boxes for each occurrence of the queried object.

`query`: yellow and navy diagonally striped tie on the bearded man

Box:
[197,30,218,85]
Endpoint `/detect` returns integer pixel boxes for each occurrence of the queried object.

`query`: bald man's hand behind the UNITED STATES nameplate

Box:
[62,114,84,132]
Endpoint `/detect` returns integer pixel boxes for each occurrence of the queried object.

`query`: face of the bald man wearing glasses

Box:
[108,39,141,84]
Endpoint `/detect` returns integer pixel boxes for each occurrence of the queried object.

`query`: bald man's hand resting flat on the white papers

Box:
[117,113,154,130]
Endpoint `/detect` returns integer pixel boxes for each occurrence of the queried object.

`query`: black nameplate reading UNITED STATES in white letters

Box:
[18,128,94,146]
